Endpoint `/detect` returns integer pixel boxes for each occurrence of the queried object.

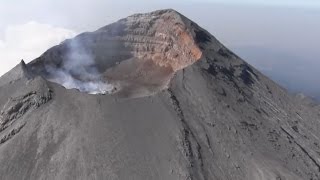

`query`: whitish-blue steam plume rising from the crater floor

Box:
[46,40,114,94]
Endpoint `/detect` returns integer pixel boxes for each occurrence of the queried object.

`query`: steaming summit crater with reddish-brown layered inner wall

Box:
[29,10,202,97]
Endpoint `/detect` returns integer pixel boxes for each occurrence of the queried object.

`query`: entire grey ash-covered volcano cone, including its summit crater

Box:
[0,10,320,180]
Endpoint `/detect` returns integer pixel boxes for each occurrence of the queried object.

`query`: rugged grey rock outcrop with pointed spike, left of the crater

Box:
[0,73,53,148]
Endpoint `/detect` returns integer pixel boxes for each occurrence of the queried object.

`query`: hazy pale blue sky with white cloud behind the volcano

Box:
[0,0,320,96]
